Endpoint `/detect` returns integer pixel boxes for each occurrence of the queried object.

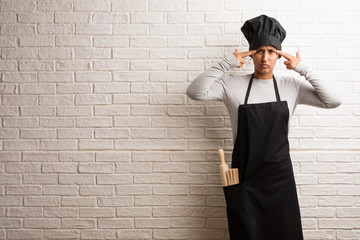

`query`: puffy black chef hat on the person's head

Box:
[241,15,286,50]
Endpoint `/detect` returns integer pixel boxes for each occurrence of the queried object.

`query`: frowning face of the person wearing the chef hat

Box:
[252,46,279,75]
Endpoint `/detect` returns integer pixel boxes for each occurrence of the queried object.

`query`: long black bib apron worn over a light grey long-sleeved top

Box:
[223,75,303,240]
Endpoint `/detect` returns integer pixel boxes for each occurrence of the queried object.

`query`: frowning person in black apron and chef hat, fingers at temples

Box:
[187,15,341,240]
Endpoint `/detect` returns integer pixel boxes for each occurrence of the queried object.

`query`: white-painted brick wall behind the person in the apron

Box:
[0,0,360,240]
